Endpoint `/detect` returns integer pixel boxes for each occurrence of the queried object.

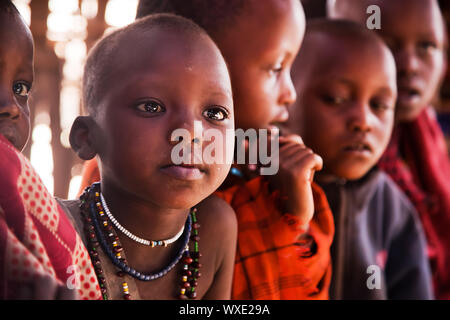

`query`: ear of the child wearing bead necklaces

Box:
[69,116,97,160]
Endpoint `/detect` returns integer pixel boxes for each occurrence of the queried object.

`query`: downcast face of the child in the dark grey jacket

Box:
[289,34,396,180]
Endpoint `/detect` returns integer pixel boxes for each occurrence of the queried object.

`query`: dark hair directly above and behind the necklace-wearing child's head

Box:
[136,0,251,34]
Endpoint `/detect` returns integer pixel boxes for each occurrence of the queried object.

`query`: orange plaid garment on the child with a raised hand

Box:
[216,177,334,300]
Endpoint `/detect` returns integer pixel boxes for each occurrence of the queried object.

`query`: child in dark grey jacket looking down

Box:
[288,19,432,299]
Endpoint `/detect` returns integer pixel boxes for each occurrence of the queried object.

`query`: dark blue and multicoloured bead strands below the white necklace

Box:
[80,183,201,300]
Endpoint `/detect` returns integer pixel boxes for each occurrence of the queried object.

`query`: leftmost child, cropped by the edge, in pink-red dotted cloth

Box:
[0,1,100,299]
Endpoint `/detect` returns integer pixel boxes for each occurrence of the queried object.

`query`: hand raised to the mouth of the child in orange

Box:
[269,135,323,226]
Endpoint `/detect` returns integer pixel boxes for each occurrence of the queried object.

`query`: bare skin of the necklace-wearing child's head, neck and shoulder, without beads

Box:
[71,23,236,299]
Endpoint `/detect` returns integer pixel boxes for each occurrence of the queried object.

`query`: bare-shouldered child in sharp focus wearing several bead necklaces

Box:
[66,15,236,299]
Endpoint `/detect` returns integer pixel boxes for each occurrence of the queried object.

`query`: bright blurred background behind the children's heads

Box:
[13,0,450,199]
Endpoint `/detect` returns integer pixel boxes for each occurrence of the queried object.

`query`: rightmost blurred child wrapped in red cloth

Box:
[329,0,450,299]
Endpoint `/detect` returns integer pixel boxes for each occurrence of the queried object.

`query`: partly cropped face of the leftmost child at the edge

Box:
[0,13,33,151]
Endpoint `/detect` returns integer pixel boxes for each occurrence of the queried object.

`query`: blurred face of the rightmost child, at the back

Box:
[328,0,446,122]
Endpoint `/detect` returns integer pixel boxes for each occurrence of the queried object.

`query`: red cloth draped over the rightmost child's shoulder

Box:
[379,107,450,299]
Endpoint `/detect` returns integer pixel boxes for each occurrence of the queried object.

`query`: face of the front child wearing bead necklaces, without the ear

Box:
[90,28,234,209]
